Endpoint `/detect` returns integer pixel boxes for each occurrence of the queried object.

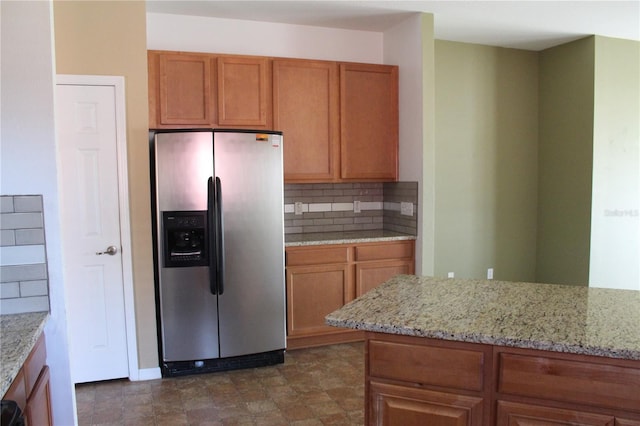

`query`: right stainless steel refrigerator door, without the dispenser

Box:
[214,132,286,357]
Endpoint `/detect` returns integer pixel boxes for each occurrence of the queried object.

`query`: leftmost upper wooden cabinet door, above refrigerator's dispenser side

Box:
[156,53,215,126]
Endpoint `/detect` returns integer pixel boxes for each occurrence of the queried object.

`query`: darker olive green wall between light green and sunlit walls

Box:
[536,37,595,285]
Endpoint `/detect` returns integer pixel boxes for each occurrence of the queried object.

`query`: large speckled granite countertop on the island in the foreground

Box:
[326,275,640,360]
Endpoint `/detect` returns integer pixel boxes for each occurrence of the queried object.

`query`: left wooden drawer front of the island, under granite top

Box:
[369,340,485,391]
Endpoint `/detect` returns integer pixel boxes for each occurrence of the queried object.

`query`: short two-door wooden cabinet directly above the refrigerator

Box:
[148,51,272,129]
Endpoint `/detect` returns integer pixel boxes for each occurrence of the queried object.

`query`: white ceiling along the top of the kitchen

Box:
[146,0,640,50]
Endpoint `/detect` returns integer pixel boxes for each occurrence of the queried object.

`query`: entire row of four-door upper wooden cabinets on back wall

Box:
[148,50,398,183]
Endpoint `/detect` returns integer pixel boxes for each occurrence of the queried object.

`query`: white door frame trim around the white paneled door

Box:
[56,74,140,380]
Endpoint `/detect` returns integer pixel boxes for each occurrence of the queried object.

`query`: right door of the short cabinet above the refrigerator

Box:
[217,56,271,129]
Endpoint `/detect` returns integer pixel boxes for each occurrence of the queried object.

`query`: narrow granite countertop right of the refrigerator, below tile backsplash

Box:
[284,230,416,247]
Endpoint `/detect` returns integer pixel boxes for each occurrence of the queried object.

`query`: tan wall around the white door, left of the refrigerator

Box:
[54,0,158,369]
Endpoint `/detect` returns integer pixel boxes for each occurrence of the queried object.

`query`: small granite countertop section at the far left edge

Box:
[0,312,49,396]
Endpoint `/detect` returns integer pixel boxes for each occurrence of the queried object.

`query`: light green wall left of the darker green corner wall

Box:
[434,40,538,281]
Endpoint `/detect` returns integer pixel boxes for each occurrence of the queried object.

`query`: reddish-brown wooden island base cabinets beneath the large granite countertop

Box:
[365,332,640,426]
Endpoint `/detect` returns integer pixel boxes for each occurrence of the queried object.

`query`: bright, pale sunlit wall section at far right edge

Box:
[589,37,640,290]
